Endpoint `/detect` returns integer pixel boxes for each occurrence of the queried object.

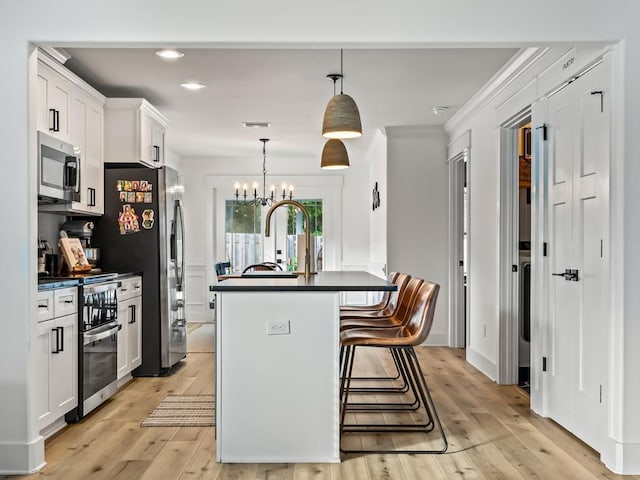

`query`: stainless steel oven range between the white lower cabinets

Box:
[66,279,122,422]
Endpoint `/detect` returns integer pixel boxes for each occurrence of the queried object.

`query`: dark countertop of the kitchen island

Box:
[209,272,398,292]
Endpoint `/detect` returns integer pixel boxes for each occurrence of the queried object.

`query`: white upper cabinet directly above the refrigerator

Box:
[104,98,168,168]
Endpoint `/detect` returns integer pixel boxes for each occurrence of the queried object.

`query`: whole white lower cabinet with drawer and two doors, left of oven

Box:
[35,287,78,430]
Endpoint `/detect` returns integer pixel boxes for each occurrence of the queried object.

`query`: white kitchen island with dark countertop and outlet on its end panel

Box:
[210,272,396,463]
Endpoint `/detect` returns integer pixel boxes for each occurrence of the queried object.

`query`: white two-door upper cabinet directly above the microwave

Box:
[38,62,73,143]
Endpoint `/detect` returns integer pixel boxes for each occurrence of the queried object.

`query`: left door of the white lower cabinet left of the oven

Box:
[34,320,55,430]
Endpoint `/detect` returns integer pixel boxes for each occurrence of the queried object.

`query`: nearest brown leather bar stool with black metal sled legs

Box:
[340,282,448,454]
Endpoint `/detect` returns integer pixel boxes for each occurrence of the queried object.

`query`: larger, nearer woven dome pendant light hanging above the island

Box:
[322,49,362,138]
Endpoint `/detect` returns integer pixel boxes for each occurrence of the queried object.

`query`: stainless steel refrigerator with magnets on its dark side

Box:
[92,164,187,376]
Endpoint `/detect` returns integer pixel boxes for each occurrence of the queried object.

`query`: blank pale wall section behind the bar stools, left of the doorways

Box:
[386,127,449,345]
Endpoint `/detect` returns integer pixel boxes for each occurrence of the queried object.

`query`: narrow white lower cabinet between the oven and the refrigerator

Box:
[118,276,142,380]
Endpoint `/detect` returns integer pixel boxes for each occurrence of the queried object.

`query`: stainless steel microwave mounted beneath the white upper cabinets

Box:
[38,132,80,204]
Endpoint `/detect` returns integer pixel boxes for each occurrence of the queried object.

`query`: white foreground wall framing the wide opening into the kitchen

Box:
[0,0,640,473]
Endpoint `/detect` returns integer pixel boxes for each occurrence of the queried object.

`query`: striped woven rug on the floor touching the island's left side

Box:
[140,395,215,427]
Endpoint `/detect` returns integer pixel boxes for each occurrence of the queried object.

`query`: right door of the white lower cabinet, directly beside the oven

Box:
[50,314,78,418]
